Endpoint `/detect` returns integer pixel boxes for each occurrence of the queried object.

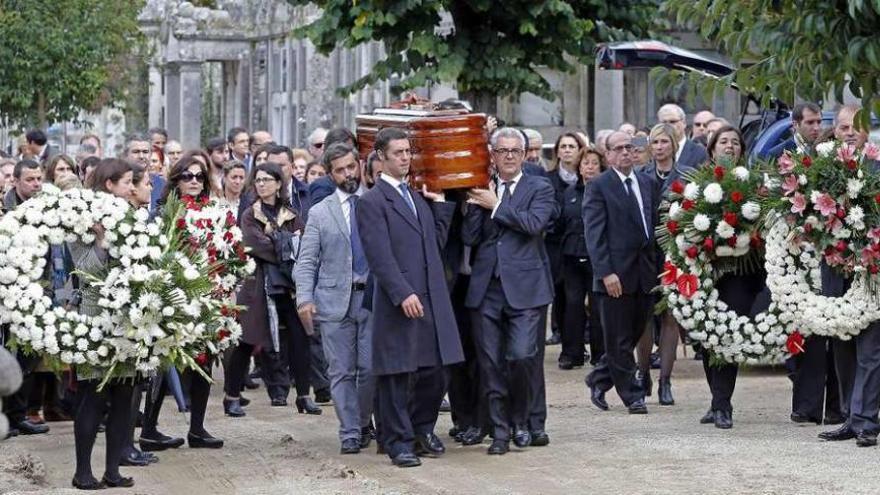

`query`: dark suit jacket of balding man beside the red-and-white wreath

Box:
[583,169,657,294]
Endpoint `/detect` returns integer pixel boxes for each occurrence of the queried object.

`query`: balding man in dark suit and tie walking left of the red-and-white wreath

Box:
[583,131,657,414]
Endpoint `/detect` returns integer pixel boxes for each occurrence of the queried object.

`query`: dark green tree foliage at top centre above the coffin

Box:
[288,0,658,101]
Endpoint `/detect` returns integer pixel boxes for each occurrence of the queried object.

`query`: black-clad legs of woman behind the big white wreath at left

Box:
[73,380,133,482]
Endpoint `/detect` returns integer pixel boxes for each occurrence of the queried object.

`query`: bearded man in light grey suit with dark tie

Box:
[294,143,374,454]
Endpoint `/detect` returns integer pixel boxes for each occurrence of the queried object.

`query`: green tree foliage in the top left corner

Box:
[0,0,144,125]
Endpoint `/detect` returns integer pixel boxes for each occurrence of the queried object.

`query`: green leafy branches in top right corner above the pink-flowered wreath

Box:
[661,0,880,128]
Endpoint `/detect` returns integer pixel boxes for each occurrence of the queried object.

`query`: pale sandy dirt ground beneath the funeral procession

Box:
[0,346,880,495]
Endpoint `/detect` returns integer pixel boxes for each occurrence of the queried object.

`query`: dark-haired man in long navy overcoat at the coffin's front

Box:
[357,127,464,467]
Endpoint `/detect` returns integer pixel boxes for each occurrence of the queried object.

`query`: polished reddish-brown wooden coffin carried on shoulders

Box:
[355,108,489,191]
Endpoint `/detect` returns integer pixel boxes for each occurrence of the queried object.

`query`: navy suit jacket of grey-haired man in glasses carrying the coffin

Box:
[462,174,559,309]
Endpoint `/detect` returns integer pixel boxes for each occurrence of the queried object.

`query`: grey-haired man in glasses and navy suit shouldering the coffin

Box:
[462,127,559,455]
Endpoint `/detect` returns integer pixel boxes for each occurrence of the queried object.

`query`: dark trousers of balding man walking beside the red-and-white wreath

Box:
[587,293,654,406]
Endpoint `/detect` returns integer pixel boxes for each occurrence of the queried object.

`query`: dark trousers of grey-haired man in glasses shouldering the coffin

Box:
[475,278,547,440]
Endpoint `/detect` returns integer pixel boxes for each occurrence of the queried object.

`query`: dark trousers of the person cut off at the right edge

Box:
[850,321,880,435]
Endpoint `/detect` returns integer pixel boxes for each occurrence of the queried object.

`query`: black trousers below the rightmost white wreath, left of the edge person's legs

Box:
[791,335,841,423]
